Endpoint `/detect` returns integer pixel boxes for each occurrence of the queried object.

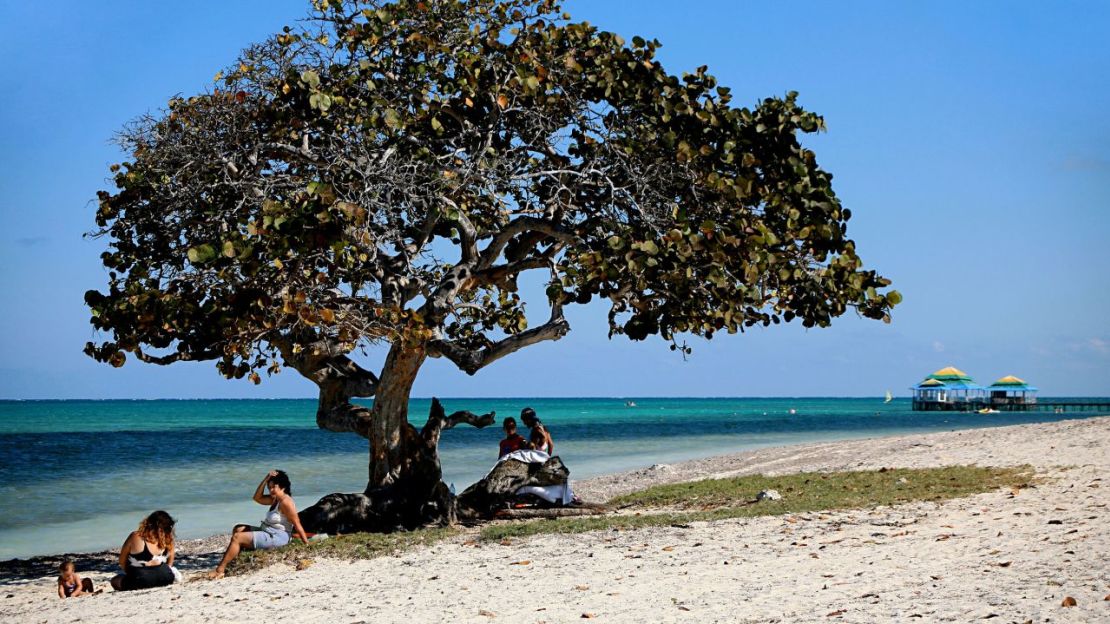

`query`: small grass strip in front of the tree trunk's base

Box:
[228,526,458,575]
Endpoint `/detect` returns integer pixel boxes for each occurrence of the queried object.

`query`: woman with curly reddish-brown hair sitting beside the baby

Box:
[111,511,176,592]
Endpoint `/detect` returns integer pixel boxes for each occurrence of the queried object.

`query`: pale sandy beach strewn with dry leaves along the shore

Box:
[0,417,1110,624]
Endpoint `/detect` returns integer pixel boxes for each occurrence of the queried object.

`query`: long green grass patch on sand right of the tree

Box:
[472,466,1032,541]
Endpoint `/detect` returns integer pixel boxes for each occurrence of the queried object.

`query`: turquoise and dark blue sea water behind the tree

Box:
[0,397,1093,560]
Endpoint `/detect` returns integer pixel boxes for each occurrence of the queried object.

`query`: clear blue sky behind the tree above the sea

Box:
[0,0,1110,399]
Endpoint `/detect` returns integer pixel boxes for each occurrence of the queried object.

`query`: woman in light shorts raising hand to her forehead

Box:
[209,470,309,578]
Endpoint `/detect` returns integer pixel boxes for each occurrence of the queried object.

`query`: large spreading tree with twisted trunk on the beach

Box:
[85,0,901,530]
